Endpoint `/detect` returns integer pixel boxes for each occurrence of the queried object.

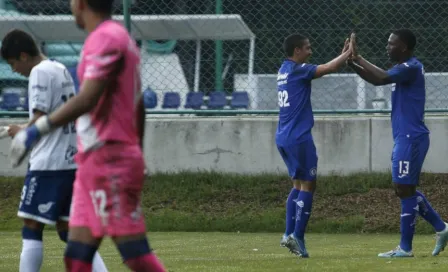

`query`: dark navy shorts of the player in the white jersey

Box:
[17,170,76,225]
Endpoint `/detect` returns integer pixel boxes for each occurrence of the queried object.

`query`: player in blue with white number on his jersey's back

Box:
[275,34,351,258]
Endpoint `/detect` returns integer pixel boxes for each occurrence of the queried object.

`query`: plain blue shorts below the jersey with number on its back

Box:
[277,139,317,181]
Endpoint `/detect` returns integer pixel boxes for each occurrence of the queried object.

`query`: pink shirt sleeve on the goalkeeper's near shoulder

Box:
[83,33,123,79]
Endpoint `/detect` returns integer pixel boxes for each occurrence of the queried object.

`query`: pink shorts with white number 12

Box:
[69,143,146,237]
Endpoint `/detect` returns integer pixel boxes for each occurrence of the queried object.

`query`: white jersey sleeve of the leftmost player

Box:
[28,70,51,113]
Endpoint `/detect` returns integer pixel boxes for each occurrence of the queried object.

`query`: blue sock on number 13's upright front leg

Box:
[400,196,418,252]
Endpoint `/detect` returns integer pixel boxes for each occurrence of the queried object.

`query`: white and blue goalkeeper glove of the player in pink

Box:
[9,116,51,168]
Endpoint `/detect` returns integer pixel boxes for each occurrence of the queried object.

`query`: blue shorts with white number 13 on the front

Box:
[392,134,429,185]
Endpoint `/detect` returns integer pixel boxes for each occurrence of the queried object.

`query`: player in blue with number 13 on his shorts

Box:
[348,29,448,258]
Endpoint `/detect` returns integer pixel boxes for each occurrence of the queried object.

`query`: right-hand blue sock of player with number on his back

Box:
[294,191,313,239]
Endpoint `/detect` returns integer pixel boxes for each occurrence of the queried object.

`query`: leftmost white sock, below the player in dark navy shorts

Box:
[19,239,44,272]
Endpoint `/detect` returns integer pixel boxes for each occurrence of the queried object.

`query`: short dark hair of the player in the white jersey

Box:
[1,29,40,60]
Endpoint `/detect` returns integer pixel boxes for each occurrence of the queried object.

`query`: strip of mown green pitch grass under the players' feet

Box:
[0,231,448,272]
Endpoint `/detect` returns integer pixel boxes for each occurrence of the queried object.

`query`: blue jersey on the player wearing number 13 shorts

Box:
[387,57,429,142]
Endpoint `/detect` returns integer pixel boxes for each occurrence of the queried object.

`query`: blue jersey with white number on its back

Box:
[275,60,317,146]
